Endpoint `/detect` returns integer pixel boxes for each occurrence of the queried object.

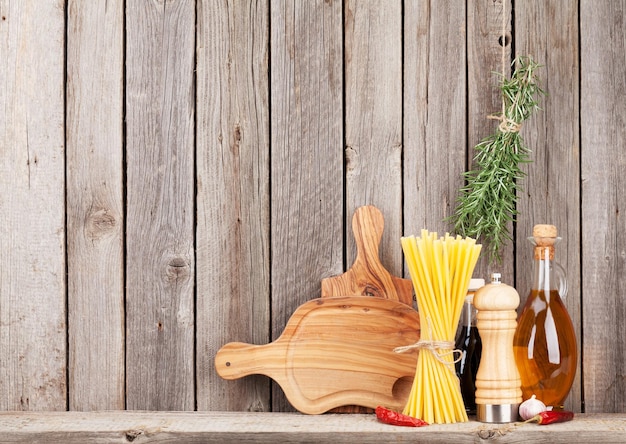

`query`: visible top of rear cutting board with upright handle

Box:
[322,205,413,306]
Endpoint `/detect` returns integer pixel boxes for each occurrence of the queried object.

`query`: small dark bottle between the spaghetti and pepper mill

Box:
[454,279,485,415]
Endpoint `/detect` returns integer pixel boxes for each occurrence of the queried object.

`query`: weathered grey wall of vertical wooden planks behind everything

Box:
[0,0,626,412]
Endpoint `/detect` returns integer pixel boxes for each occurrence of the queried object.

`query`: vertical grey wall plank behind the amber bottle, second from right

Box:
[515,0,582,412]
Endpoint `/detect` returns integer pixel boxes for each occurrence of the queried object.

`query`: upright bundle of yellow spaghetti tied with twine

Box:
[396,230,481,424]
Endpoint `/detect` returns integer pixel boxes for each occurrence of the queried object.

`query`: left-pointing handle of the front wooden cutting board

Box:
[215,341,286,383]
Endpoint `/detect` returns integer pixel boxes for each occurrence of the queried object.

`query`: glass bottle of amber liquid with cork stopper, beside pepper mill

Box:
[513,225,577,407]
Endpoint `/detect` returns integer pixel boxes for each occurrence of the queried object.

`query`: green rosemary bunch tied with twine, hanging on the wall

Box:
[449,57,544,262]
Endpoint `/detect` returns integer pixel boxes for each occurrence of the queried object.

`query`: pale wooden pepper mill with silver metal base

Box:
[474,273,522,423]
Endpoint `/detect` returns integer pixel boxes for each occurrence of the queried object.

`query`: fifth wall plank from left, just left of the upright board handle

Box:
[270,0,343,410]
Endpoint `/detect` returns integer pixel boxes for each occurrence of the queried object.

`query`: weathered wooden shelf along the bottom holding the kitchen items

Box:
[0,411,626,444]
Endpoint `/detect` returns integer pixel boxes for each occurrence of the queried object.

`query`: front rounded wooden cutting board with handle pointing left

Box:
[215,296,419,414]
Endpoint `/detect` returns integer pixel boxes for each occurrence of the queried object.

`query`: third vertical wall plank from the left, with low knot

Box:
[126,0,195,410]
